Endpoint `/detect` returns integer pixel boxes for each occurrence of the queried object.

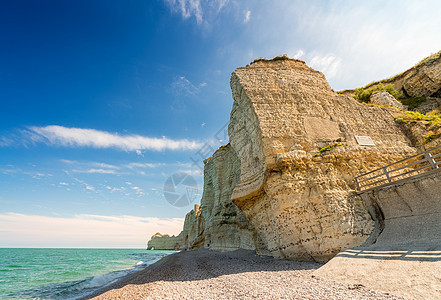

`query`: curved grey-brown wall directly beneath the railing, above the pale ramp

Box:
[361,169,441,246]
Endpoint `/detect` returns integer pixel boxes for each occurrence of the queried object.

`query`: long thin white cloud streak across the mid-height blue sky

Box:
[28,125,202,151]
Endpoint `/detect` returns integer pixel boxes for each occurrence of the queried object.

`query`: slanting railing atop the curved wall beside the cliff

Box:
[355,146,441,191]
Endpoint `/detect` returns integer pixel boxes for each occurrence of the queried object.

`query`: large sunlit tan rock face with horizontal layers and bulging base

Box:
[229,60,414,261]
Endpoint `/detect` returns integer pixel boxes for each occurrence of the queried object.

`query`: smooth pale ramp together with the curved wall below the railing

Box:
[314,169,441,299]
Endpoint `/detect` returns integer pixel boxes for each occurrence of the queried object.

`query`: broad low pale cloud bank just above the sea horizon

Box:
[0,213,184,248]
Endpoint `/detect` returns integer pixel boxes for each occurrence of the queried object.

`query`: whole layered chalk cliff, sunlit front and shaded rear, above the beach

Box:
[149,52,441,261]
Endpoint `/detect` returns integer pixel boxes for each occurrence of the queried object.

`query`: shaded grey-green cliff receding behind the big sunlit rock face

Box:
[149,144,256,251]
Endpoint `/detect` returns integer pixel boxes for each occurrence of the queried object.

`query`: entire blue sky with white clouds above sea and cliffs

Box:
[0,0,441,248]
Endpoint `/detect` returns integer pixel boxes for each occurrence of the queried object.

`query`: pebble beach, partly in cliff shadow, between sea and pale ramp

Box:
[88,249,403,299]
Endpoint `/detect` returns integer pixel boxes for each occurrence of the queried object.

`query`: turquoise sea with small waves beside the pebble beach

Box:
[0,248,175,300]
